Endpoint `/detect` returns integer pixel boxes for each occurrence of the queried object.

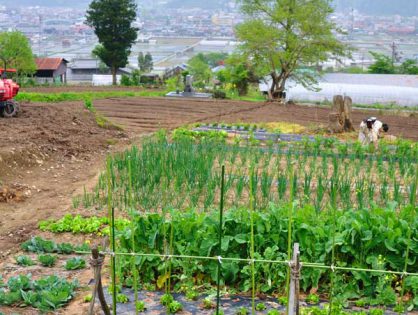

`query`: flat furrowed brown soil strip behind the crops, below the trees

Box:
[94,98,418,140]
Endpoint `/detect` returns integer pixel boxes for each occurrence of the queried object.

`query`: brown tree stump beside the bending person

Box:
[328,95,354,133]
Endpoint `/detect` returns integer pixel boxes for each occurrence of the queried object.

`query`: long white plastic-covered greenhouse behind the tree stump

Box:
[260,74,418,106]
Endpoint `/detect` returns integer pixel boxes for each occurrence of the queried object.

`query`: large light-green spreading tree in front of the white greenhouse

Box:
[236,0,348,99]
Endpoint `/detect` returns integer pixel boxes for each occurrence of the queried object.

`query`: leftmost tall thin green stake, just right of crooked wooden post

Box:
[106,157,116,314]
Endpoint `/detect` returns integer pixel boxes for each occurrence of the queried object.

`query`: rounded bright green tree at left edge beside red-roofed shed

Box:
[0,31,36,76]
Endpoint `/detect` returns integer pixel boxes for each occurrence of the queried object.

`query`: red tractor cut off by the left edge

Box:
[0,67,20,118]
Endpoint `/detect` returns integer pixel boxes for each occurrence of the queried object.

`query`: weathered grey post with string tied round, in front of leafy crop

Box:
[287,243,301,315]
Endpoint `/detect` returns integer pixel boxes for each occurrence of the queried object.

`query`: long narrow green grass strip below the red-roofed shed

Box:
[16,90,165,103]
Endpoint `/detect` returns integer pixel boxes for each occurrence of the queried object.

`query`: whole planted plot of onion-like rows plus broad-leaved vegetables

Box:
[77,134,418,310]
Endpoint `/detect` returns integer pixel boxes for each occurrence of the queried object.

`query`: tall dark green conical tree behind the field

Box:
[86,0,138,84]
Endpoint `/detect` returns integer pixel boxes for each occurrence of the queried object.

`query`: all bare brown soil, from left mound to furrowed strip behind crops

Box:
[0,95,418,314]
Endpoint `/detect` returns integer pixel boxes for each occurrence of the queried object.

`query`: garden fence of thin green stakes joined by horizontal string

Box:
[82,163,418,314]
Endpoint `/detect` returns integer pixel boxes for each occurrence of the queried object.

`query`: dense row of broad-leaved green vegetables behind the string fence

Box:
[112,206,418,312]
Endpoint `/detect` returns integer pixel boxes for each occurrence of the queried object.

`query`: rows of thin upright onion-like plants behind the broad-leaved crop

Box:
[77,133,418,211]
